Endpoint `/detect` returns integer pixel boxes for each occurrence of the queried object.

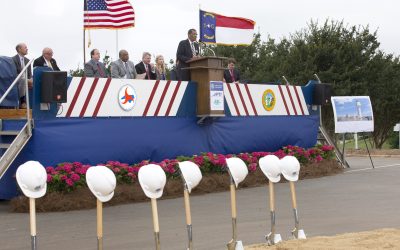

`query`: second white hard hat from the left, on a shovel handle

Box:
[86,166,117,202]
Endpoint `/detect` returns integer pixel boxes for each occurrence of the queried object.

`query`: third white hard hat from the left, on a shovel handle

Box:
[138,164,167,199]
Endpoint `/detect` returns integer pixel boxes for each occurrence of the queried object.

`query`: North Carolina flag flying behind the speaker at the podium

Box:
[200,10,256,45]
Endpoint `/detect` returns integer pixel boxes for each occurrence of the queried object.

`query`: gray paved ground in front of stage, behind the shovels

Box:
[0,157,400,250]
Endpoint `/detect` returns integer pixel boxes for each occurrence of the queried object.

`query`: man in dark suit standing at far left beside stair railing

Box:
[13,43,33,108]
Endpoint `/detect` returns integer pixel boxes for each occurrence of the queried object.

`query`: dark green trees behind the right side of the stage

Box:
[206,20,400,148]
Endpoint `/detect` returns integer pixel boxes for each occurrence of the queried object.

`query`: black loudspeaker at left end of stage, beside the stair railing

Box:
[40,71,67,103]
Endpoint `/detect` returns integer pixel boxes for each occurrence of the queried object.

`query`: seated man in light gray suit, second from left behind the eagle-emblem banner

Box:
[111,49,137,79]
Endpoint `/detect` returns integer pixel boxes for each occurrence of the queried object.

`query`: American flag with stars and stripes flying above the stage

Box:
[83,0,135,29]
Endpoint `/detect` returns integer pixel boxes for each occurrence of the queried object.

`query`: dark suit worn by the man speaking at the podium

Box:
[176,39,199,81]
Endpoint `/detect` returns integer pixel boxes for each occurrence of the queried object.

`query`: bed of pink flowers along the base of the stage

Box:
[46,145,334,192]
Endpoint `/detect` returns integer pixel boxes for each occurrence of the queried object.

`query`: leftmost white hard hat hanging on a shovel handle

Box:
[16,161,47,198]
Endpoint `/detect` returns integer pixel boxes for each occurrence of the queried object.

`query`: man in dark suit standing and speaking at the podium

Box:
[176,29,199,81]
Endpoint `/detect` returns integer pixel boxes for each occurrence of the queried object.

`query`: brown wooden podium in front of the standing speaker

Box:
[187,56,227,117]
